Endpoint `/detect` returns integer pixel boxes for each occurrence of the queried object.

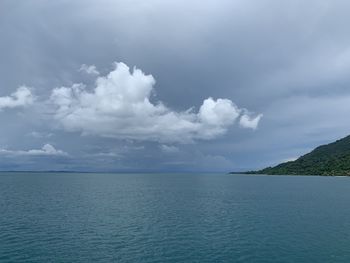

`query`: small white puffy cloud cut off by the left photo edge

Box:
[0,86,34,110]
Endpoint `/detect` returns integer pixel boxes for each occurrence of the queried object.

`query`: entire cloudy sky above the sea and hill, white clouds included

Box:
[0,0,350,172]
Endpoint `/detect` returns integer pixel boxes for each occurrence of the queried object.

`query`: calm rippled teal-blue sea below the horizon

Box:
[0,173,350,263]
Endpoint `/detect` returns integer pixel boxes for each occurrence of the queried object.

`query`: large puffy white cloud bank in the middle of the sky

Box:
[50,63,261,143]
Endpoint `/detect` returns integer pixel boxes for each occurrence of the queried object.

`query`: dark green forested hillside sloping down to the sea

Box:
[238,136,350,176]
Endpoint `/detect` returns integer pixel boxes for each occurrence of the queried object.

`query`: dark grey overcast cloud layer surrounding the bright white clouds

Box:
[0,0,350,171]
